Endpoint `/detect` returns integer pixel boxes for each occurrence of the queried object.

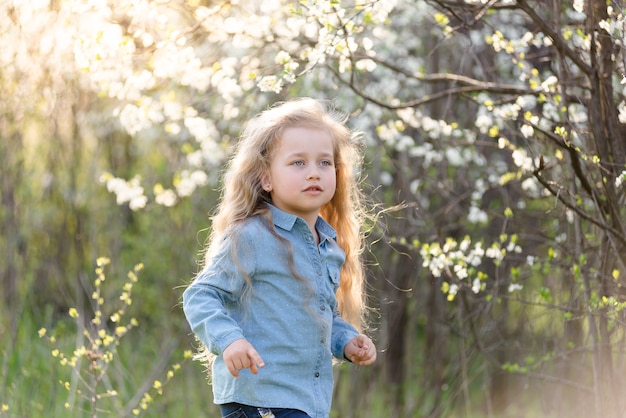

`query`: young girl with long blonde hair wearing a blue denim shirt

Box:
[183,99,376,418]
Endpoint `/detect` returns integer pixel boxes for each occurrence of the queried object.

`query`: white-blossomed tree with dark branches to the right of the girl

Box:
[320,1,626,416]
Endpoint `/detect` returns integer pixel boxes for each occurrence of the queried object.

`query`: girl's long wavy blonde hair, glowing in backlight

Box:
[205,98,365,329]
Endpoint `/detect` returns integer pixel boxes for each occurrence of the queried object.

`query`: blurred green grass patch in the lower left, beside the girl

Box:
[0,308,218,418]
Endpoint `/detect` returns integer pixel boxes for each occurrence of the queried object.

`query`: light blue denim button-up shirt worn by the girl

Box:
[183,205,357,418]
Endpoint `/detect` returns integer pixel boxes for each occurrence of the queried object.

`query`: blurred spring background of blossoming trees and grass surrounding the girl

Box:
[0,0,626,418]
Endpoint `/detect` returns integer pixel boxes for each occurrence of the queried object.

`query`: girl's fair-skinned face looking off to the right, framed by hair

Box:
[262,127,337,225]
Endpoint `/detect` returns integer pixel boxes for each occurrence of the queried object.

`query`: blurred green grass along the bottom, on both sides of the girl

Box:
[0,306,616,418]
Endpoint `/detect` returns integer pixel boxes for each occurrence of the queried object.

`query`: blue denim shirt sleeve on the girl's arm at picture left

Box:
[183,230,254,355]
